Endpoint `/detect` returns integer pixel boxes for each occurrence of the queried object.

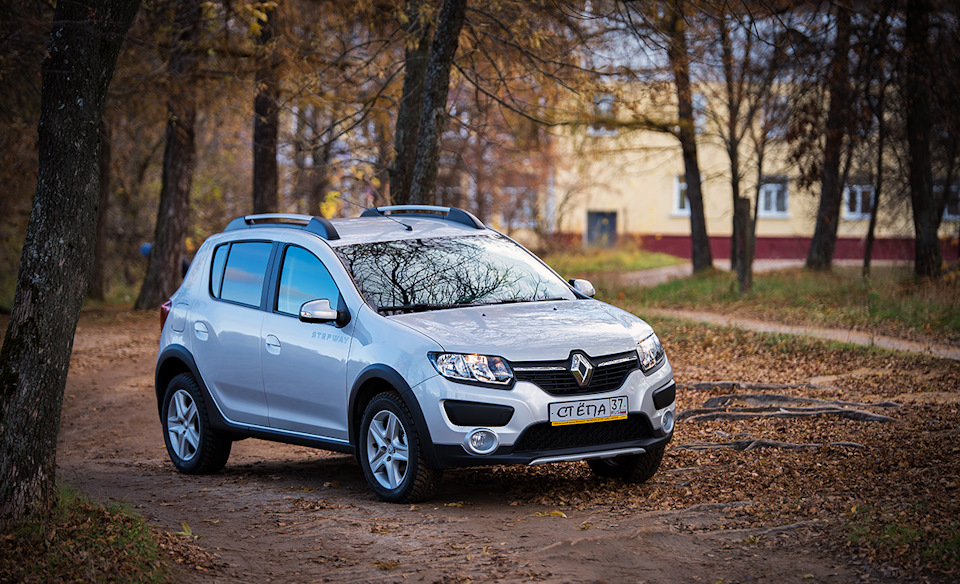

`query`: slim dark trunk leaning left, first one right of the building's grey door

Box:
[667,6,713,272]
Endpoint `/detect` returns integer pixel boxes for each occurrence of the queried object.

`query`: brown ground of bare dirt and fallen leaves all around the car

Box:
[6,313,960,583]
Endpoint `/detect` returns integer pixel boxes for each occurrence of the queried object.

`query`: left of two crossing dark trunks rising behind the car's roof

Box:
[390,0,433,205]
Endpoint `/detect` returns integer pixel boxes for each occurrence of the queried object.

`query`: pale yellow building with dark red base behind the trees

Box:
[546,96,960,259]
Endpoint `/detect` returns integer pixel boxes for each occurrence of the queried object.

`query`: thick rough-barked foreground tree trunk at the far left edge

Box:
[0,0,139,531]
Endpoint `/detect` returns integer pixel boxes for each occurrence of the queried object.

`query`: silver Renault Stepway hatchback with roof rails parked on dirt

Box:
[156,206,676,502]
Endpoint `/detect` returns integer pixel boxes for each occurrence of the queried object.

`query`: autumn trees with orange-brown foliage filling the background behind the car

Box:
[0,0,960,308]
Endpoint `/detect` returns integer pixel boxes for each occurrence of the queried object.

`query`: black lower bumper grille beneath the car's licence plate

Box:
[513,414,653,452]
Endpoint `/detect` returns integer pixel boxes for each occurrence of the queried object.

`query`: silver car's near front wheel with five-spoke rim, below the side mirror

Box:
[358,393,443,503]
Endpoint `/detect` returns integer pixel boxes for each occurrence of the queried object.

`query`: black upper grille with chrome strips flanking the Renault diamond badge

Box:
[512,351,640,395]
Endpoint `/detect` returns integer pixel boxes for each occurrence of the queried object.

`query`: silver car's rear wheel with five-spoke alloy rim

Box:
[161,373,232,474]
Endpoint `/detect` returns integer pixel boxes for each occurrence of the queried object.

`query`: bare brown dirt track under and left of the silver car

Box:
[58,314,875,583]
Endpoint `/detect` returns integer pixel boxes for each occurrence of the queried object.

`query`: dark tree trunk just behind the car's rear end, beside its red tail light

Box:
[134,0,202,310]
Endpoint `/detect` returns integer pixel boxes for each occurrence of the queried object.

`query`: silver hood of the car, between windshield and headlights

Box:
[390,300,653,361]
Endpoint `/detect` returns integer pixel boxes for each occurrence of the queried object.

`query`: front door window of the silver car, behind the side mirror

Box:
[277,245,340,315]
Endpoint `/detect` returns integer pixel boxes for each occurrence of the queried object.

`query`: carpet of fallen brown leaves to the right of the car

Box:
[458,322,960,581]
